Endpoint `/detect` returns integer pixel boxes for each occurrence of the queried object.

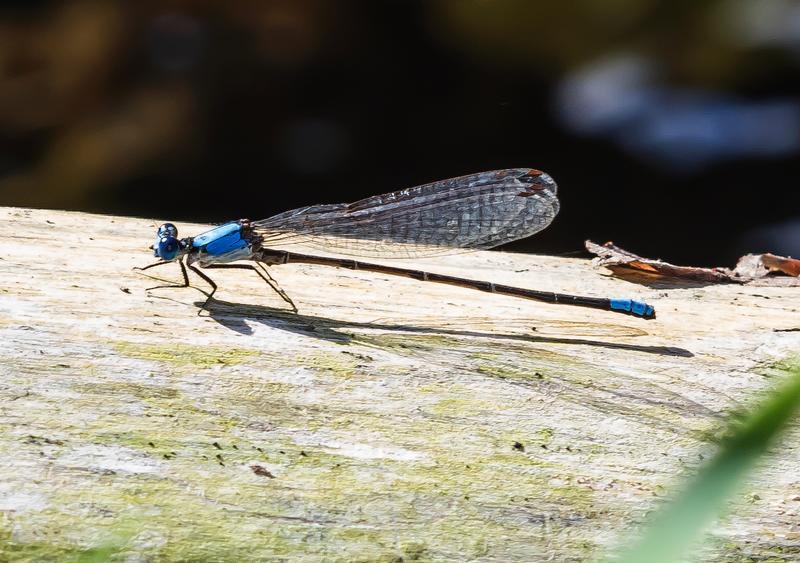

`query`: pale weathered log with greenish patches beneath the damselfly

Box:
[0,208,800,561]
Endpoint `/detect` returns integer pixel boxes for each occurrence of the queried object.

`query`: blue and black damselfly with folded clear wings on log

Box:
[142,168,655,319]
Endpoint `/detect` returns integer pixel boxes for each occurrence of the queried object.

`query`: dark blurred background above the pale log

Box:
[0,0,800,265]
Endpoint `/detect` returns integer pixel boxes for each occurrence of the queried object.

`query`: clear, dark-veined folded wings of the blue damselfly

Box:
[252,168,559,258]
